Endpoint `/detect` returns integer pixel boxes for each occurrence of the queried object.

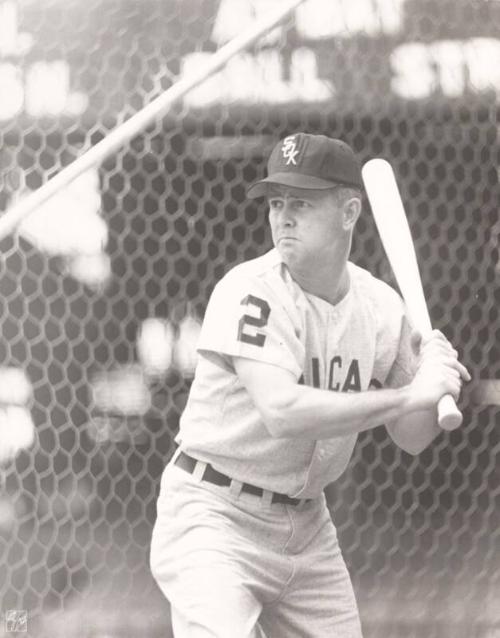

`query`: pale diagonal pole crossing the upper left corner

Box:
[0,0,304,239]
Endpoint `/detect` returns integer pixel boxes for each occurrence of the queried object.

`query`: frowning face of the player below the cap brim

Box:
[268,185,345,267]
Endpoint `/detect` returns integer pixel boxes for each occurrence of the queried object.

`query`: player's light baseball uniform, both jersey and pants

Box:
[151,249,415,638]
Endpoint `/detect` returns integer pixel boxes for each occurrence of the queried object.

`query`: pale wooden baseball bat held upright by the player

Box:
[362,158,462,430]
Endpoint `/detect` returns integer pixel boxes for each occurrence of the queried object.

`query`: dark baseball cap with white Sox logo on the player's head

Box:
[247,133,363,198]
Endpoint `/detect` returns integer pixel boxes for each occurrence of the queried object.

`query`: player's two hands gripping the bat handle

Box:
[410,330,471,410]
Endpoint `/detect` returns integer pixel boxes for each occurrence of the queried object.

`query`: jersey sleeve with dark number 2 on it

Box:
[198,275,305,378]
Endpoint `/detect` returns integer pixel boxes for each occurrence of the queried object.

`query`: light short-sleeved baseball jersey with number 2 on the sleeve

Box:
[177,250,415,498]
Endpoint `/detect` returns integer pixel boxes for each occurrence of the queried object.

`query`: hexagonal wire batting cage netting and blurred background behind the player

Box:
[0,0,500,638]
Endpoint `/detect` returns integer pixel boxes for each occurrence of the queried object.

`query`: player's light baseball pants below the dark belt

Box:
[151,463,361,638]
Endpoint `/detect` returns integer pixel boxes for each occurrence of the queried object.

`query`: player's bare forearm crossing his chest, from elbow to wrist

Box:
[263,385,417,439]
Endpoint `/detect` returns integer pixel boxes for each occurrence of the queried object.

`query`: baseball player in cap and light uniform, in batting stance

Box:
[151,133,470,638]
